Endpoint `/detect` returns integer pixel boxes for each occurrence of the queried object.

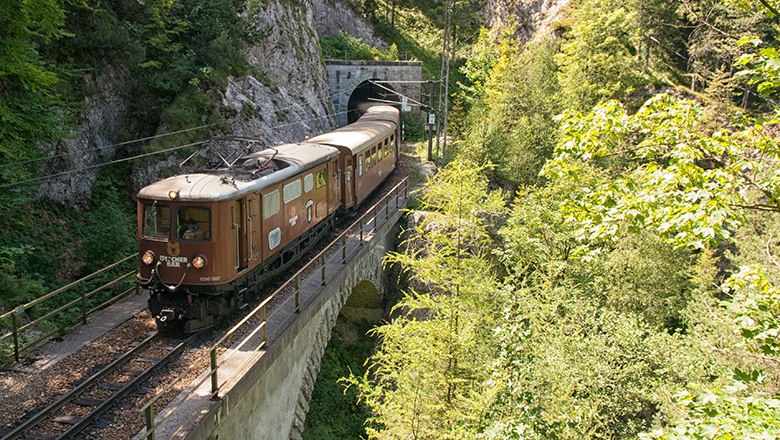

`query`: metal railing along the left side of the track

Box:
[0,253,138,362]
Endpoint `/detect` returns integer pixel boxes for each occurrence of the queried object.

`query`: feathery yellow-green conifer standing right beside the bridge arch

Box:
[346,161,502,439]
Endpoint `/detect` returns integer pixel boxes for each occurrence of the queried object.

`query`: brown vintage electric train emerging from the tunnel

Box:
[136,105,401,333]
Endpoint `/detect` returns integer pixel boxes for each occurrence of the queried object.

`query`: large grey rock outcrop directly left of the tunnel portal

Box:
[222,0,334,146]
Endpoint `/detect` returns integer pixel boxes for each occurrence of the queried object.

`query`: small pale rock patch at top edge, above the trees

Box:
[484,0,569,41]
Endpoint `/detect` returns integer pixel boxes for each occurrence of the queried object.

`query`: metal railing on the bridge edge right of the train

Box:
[140,178,409,440]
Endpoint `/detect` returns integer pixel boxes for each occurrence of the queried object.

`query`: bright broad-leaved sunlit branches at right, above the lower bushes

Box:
[543,95,780,248]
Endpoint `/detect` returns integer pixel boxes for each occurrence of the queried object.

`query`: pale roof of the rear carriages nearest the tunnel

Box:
[308,105,400,155]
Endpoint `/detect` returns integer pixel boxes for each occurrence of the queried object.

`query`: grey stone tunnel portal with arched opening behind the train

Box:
[325,60,422,125]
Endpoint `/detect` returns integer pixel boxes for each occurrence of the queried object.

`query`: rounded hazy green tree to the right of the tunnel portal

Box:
[459,32,561,186]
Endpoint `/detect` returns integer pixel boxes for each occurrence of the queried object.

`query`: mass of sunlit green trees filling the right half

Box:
[348,0,780,439]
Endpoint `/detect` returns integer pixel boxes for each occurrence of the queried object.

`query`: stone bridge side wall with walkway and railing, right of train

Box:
[136,179,409,440]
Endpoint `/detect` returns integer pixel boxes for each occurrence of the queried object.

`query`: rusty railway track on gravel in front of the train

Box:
[0,333,197,440]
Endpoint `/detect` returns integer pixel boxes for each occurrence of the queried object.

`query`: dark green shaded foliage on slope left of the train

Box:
[0,0,253,348]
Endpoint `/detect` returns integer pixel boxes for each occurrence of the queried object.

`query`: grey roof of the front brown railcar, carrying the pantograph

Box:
[138,143,339,201]
